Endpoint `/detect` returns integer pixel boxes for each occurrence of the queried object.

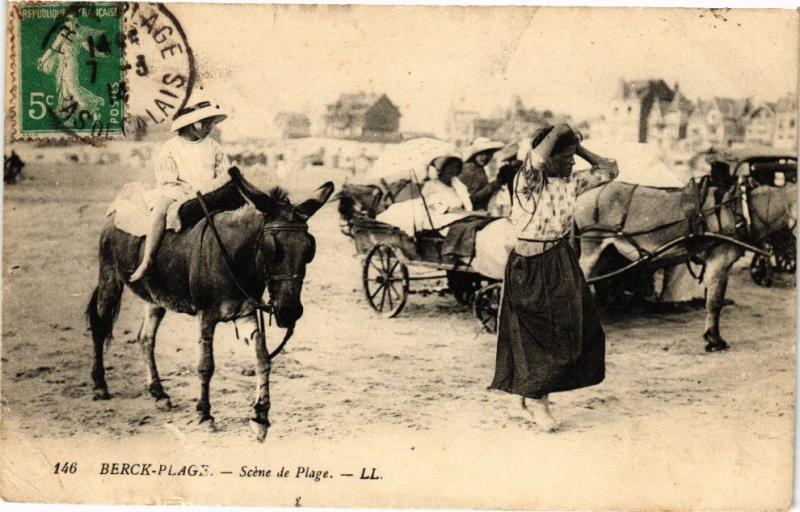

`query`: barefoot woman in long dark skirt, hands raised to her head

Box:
[489,124,619,431]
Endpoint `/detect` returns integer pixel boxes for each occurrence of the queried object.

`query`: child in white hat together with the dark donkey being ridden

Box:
[94,102,333,441]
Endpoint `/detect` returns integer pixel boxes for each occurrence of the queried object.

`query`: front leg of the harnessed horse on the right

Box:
[703,245,741,352]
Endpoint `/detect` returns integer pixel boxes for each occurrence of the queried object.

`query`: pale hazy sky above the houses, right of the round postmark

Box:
[169,4,797,136]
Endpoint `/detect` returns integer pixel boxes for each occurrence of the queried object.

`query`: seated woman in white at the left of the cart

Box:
[376,155,472,236]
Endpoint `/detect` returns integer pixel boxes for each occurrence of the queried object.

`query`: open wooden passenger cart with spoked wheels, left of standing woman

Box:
[348,216,500,332]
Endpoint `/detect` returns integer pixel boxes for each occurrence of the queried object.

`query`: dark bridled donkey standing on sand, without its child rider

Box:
[86,172,333,441]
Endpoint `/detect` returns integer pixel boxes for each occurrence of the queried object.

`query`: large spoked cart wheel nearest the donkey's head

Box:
[362,245,408,318]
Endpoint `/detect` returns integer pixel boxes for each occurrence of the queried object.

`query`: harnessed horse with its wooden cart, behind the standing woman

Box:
[339,140,796,352]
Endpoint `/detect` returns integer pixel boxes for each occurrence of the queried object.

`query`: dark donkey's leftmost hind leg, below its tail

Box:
[86,268,124,400]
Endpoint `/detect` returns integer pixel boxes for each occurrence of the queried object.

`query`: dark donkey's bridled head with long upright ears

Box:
[252,182,333,328]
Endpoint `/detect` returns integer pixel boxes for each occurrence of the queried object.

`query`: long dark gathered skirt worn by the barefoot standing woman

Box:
[489,242,606,398]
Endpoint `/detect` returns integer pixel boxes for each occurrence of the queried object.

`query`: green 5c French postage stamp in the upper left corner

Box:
[11,3,125,139]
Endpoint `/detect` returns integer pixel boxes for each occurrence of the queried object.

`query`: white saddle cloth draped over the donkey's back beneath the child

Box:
[106,182,192,236]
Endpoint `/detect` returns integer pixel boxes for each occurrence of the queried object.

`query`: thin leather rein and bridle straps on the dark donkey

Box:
[197,192,308,361]
